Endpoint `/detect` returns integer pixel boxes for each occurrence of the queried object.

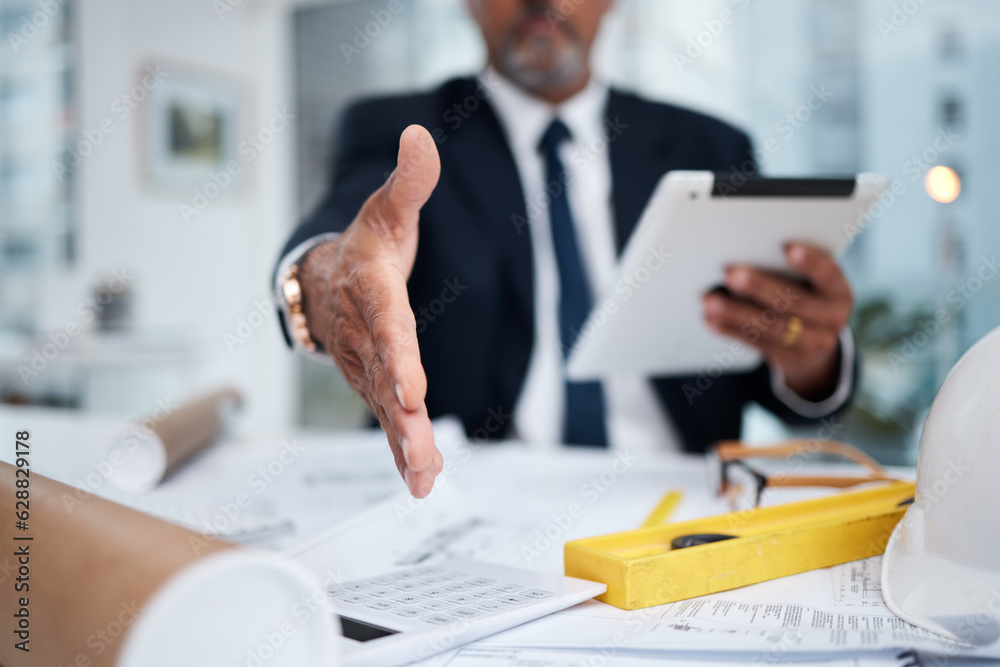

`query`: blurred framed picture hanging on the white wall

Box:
[144,64,244,188]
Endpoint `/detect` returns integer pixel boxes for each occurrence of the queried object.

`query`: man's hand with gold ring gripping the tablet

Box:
[705,243,854,400]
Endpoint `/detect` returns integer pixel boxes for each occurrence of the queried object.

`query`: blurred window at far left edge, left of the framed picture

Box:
[0,0,72,332]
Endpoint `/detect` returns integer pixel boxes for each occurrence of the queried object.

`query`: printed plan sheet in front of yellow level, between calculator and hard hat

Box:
[484,557,1000,660]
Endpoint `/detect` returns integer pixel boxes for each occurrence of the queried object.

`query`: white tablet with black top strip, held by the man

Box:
[568,171,888,379]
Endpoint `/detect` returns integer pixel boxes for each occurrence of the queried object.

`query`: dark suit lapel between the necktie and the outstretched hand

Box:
[442,79,534,332]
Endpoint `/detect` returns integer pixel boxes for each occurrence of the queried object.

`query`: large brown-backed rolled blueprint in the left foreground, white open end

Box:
[0,464,337,667]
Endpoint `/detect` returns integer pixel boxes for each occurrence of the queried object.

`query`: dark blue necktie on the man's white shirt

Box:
[538,118,608,447]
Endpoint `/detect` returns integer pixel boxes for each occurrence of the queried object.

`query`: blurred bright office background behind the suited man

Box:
[0,0,1000,462]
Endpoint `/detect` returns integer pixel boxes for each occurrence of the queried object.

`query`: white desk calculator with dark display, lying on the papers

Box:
[327,559,607,667]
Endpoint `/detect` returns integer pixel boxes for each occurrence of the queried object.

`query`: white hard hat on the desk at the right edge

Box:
[882,328,1000,645]
